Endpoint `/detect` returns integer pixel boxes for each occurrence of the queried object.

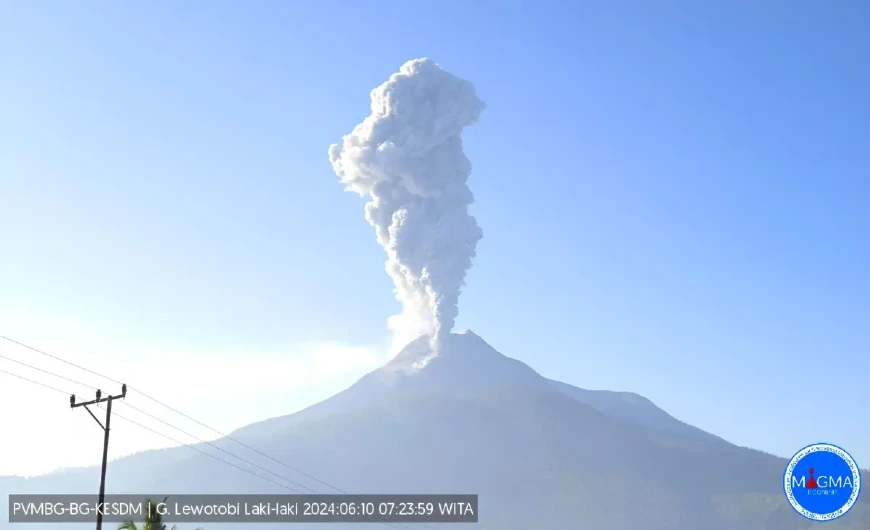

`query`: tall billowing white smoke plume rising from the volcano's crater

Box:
[329,59,484,347]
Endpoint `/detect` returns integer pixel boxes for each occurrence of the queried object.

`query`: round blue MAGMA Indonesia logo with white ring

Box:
[783,444,861,521]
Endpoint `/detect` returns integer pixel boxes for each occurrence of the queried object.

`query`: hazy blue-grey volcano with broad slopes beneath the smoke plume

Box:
[0,332,870,530]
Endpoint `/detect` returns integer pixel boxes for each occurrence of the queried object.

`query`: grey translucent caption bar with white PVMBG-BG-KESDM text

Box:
[9,495,477,523]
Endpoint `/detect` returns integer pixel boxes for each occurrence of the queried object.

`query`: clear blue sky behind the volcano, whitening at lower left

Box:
[0,0,870,474]
